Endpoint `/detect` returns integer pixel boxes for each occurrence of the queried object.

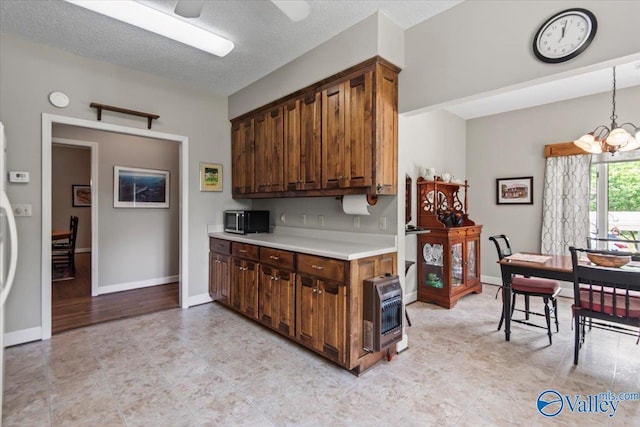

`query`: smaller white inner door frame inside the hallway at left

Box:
[50,137,100,297]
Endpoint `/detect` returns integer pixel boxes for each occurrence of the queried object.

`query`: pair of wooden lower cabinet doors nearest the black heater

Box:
[296,274,347,364]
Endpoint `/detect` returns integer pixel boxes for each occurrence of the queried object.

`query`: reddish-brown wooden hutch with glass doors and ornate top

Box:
[417,178,482,308]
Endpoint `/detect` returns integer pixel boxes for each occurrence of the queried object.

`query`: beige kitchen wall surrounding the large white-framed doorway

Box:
[0,34,231,339]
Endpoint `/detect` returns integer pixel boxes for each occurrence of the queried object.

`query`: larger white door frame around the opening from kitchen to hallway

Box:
[40,113,189,340]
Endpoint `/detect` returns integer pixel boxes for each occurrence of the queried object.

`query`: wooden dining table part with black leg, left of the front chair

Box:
[499,253,573,341]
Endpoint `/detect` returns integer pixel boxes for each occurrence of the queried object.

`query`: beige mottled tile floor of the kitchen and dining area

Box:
[2,286,640,426]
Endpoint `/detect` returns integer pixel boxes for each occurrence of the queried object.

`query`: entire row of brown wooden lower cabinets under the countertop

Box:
[209,238,397,375]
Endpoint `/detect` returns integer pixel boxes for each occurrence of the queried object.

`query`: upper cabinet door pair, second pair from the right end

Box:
[284,91,321,191]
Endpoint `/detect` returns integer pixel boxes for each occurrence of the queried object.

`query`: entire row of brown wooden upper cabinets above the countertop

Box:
[232,57,400,198]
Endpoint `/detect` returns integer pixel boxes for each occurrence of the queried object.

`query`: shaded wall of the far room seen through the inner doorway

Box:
[51,144,91,251]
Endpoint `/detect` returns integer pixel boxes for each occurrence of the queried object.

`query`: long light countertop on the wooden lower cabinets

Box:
[208,227,398,261]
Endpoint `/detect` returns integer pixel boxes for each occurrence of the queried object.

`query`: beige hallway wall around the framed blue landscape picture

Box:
[52,125,180,293]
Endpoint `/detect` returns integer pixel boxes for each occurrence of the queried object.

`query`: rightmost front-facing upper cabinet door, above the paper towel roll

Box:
[344,71,373,187]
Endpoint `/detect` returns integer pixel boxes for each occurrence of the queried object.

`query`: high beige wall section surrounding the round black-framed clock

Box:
[399,0,640,113]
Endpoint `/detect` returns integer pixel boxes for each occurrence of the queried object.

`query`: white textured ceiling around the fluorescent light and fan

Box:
[0,0,460,95]
